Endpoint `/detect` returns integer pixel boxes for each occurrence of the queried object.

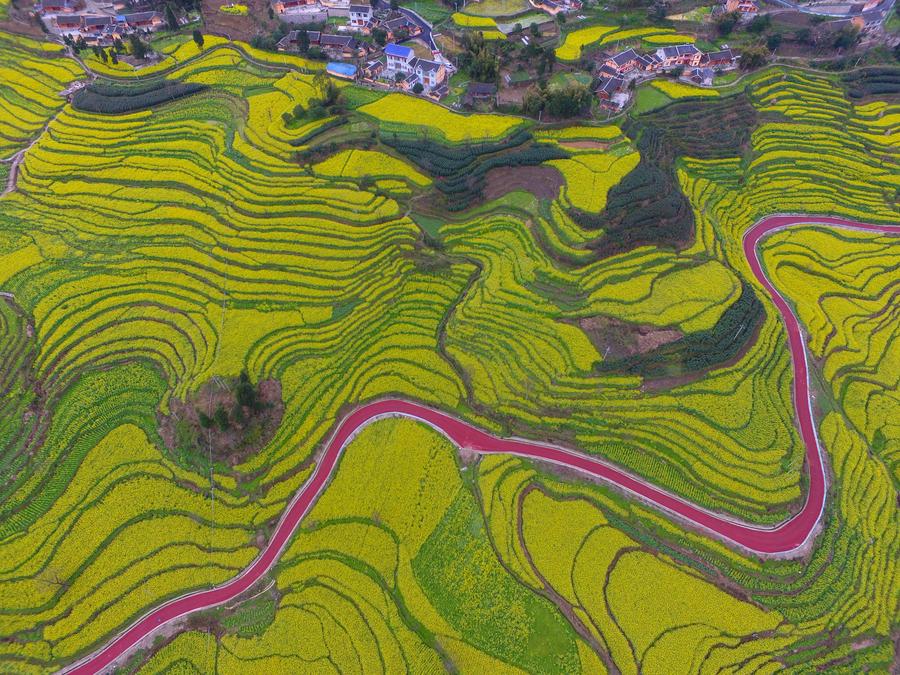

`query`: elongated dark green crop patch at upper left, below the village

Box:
[72,80,207,115]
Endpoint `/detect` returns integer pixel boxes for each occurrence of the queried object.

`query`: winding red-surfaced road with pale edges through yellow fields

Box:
[64,215,900,675]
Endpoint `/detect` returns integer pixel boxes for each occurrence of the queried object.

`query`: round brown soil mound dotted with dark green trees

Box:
[157,373,284,467]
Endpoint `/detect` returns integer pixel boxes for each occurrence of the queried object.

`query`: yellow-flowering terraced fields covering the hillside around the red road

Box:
[0,29,900,672]
